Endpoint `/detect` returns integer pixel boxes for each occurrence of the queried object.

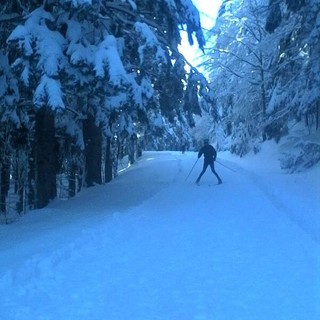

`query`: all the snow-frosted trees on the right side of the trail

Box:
[203,0,320,166]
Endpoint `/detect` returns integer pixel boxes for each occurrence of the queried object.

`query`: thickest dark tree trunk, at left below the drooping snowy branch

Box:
[35,108,57,209]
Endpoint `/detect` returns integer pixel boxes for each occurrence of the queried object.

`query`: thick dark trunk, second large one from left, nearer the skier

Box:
[83,115,102,187]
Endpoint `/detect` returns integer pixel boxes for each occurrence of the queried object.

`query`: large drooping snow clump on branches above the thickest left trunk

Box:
[7,8,65,109]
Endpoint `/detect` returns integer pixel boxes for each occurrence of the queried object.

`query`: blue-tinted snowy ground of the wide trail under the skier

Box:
[0,145,320,320]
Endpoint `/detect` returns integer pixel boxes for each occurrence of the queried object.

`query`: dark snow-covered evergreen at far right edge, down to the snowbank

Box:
[268,0,320,172]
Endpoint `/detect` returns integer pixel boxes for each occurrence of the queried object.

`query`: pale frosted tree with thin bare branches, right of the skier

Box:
[204,1,270,155]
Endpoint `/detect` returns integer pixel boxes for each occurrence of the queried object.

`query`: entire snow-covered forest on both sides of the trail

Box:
[0,0,320,223]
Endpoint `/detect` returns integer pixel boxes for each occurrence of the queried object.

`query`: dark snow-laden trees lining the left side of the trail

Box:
[0,0,214,222]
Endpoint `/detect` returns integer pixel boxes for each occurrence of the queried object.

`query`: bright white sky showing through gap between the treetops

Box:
[179,0,222,66]
